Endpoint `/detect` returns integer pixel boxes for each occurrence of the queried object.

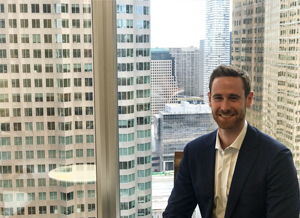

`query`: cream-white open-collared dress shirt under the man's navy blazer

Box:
[212,121,247,218]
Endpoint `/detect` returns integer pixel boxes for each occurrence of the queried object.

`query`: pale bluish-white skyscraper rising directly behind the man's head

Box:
[203,0,230,103]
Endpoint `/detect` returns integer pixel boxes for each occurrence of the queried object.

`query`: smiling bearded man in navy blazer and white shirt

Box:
[163,65,299,218]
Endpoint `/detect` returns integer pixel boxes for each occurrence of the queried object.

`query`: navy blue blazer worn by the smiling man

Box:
[163,124,300,218]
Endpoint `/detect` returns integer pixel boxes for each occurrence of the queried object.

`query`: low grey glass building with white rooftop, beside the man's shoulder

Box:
[154,101,217,171]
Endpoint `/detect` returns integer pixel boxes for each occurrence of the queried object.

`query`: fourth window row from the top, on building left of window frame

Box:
[2,49,92,58]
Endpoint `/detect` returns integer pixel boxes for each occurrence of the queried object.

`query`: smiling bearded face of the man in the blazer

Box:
[208,77,253,131]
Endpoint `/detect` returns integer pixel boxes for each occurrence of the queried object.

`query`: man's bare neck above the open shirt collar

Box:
[219,120,245,150]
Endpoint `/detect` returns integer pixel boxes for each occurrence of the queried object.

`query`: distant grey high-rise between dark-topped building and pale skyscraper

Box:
[169,47,199,97]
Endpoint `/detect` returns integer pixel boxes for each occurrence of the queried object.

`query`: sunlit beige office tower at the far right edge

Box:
[262,0,300,174]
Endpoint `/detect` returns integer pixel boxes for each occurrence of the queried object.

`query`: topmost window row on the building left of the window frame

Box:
[0,4,92,13]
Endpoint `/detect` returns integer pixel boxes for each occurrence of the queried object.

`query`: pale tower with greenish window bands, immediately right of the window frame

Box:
[117,0,152,218]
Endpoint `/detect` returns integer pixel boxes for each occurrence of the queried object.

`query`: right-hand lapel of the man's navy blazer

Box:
[225,124,259,218]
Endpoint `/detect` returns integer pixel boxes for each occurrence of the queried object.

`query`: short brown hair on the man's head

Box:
[209,65,251,98]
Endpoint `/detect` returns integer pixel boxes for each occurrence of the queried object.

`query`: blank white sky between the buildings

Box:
[150,0,231,48]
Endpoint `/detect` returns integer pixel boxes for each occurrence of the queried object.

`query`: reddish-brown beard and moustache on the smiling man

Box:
[212,107,246,130]
